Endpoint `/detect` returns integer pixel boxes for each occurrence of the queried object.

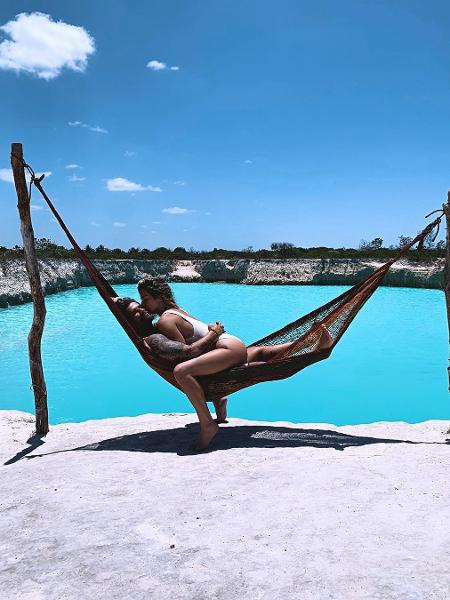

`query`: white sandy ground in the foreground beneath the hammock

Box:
[0,411,450,600]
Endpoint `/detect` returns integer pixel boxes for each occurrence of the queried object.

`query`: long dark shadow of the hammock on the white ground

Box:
[5,423,450,465]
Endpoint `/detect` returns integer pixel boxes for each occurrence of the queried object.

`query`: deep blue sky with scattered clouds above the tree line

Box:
[0,0,450,249]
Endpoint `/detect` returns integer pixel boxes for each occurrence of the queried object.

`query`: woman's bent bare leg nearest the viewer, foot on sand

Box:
[173,340,247,450]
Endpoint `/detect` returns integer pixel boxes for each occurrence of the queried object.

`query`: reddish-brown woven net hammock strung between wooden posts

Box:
[31,178,442,401]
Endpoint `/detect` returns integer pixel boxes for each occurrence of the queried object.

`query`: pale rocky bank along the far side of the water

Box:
[0,259,444,308]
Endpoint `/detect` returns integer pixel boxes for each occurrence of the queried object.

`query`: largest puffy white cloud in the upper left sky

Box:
[0,12,95,81]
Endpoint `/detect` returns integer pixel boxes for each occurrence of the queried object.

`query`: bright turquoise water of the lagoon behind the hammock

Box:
[0,283,450,425]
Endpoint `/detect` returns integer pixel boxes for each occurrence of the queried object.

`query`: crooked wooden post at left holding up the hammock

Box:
[11,144,48,435]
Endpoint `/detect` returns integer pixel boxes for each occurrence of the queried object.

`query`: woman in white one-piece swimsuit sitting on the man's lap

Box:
[138,279,331,450]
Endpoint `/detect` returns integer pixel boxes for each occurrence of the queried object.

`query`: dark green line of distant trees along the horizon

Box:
[0,235,445,260]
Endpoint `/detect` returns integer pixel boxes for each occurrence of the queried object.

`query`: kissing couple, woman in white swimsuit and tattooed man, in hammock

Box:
[114,279,325,450]
